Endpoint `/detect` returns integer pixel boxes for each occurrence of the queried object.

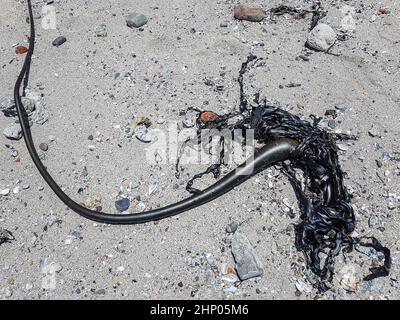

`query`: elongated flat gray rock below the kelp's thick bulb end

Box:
[232,233,263,281]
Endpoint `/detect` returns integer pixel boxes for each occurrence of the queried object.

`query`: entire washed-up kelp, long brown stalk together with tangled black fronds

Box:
[14,0,391,291]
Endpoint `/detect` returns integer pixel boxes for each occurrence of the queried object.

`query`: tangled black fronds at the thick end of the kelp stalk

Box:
[183,55,391,291]
